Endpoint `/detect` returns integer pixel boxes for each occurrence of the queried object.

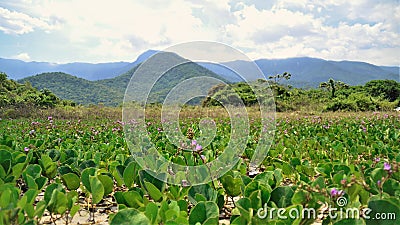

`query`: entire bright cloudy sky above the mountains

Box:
[0,0,400,66]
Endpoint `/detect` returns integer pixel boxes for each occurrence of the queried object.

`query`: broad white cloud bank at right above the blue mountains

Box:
[226,0,400,65]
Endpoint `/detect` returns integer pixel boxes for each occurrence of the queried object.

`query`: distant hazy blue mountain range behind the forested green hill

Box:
[0,50,400,87]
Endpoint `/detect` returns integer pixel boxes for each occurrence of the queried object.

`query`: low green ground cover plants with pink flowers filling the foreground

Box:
[0,107,400,224]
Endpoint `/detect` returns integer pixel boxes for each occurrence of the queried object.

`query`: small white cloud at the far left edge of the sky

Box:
[0,7,51,34]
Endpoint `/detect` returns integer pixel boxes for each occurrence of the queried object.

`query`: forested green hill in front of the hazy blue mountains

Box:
[19,53,226,106]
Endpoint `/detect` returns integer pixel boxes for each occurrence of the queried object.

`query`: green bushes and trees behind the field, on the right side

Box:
[203,78,400,112]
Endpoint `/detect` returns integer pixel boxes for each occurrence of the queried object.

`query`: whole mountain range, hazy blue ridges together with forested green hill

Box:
[0,50,400,105]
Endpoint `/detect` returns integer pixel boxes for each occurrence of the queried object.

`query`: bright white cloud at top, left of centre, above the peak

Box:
[29,0,216,46]
